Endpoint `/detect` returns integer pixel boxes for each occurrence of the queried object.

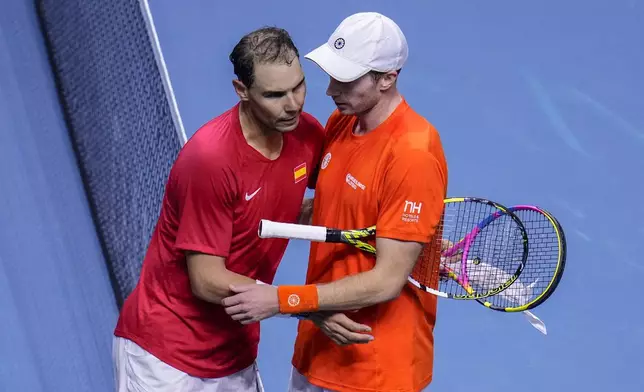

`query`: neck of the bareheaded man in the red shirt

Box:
[239,102,284,159]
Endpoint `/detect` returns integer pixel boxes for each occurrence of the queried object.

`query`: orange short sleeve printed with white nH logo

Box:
[376,150,447,242]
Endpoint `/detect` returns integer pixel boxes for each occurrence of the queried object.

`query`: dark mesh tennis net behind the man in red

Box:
[37,0,182,306]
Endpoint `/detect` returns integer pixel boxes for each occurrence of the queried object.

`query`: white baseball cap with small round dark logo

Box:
[304,12,408,82]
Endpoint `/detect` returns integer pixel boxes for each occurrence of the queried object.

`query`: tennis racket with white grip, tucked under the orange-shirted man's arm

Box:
[258,197,528,300]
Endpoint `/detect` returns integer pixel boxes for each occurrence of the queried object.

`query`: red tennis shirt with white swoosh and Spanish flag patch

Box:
[115,104,324,378]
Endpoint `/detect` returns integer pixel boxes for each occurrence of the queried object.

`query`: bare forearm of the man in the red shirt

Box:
[187,253,256,305]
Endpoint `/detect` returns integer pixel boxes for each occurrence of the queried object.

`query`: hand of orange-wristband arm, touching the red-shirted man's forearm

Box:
[221,284,279,324]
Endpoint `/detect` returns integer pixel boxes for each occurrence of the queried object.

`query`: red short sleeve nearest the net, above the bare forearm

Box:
[175,153,236,257]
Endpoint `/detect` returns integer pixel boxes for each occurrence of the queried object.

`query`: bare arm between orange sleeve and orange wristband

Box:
[317,238,422,311]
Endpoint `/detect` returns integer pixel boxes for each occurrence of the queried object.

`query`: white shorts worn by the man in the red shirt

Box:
[112,336,264,392]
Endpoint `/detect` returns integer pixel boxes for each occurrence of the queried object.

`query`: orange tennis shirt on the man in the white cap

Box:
[292,100,447,392]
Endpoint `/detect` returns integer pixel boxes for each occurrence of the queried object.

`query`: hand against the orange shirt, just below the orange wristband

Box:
[309,312,374,346]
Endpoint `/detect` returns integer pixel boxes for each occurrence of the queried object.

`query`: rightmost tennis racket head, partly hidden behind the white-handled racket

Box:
[476,205,566,312]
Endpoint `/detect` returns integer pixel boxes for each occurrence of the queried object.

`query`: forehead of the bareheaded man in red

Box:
[254,58,304,91]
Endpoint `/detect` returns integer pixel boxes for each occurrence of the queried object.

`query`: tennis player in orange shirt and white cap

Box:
[224,12,447,392]
